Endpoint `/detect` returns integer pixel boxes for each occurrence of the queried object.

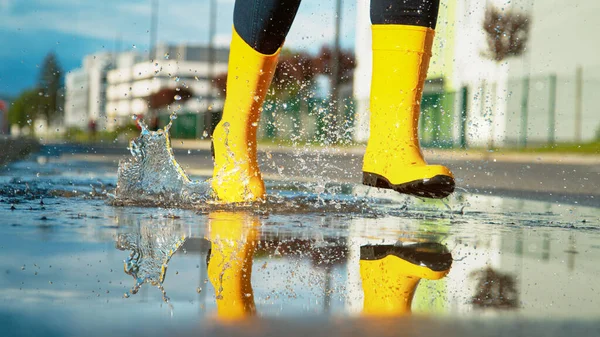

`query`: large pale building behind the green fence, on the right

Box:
[354,0,600,146]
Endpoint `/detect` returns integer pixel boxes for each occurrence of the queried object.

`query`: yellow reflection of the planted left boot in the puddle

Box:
[208,211,259,321]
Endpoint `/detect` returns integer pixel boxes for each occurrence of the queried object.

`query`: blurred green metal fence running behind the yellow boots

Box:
[161,68,600,148]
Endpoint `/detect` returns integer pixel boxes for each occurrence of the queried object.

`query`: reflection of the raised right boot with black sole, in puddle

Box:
[360,243,452,316]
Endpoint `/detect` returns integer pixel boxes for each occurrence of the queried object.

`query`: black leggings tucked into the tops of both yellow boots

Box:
[233,0,440,54]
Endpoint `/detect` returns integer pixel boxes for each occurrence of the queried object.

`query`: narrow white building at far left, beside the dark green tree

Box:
[64,53,114,128]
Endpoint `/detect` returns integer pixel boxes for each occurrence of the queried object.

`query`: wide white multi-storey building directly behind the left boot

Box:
[105,44,229,129]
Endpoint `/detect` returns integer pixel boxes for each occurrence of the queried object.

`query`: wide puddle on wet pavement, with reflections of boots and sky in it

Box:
[0,144,600,336]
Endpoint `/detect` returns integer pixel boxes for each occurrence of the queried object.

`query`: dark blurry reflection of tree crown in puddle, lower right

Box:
[469,267,519,310]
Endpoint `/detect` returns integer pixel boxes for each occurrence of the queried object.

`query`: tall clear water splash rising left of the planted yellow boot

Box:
[115,112,211,206]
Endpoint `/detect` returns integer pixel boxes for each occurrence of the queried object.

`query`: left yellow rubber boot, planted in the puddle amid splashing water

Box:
[212,28,280,203]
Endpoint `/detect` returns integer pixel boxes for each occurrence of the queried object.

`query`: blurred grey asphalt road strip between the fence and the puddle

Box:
[40,144,600,207]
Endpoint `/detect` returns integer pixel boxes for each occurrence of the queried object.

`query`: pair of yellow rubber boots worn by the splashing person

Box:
[212,25,454,203]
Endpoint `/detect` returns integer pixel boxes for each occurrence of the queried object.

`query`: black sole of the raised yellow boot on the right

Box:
[363,172,454,199]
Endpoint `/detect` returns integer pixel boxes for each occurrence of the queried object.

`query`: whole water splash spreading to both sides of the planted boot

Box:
[109,111,390,214]
